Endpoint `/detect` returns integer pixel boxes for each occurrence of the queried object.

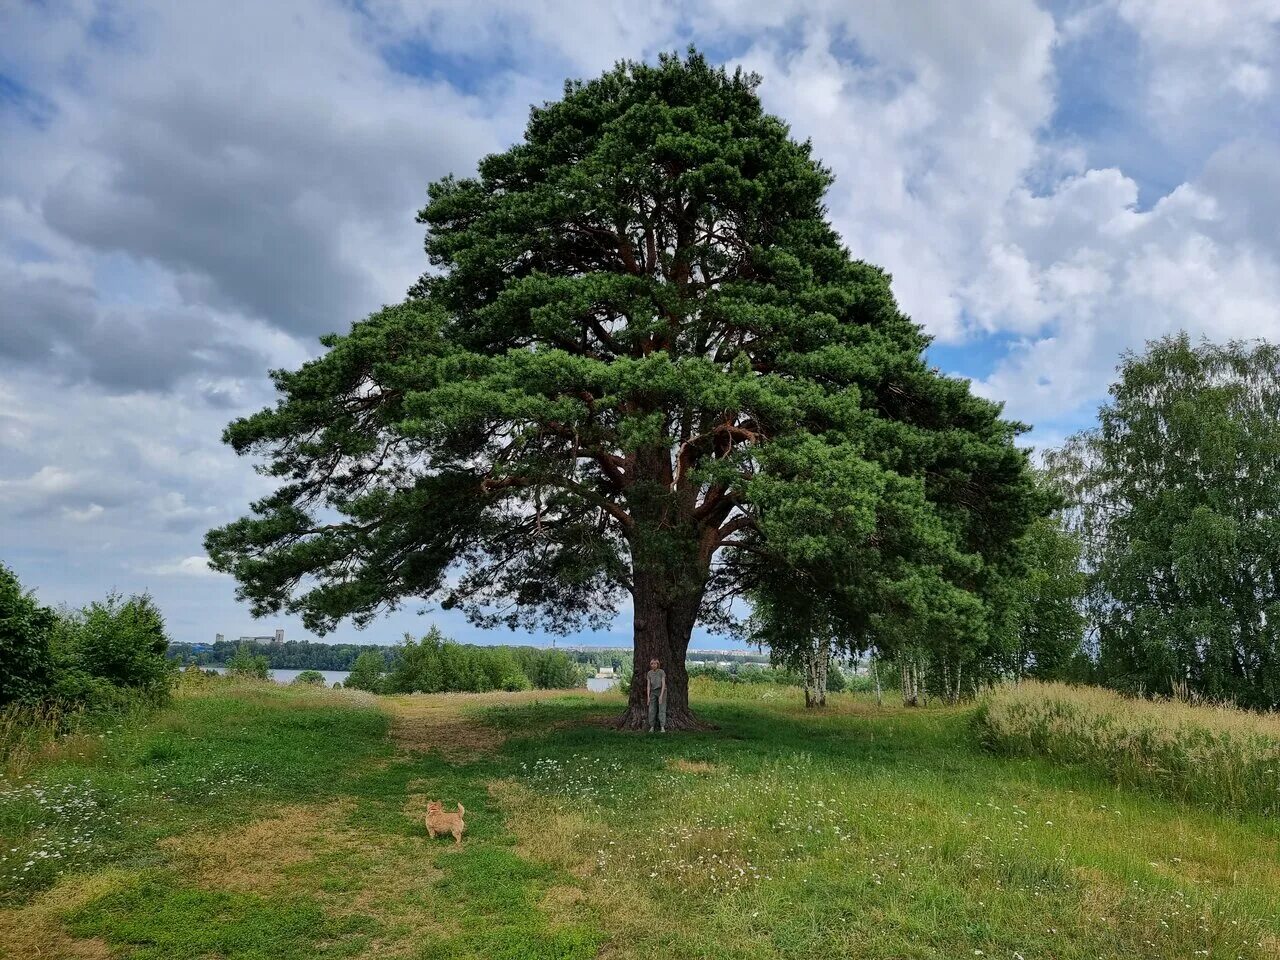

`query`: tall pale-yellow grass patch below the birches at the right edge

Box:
[978,682,1280,815]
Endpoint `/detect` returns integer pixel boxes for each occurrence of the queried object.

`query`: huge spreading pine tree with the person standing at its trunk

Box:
[207,52,1032,727]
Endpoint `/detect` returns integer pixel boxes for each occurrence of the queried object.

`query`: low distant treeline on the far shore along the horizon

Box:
[168,640,769,673]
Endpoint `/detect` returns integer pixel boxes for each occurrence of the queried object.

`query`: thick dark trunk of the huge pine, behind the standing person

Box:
[618,572,708,730]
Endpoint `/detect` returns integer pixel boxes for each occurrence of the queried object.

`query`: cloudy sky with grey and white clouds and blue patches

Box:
[0,0,1280,645]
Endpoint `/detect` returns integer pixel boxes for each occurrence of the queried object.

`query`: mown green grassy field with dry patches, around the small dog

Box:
[0,684,1280,960]
